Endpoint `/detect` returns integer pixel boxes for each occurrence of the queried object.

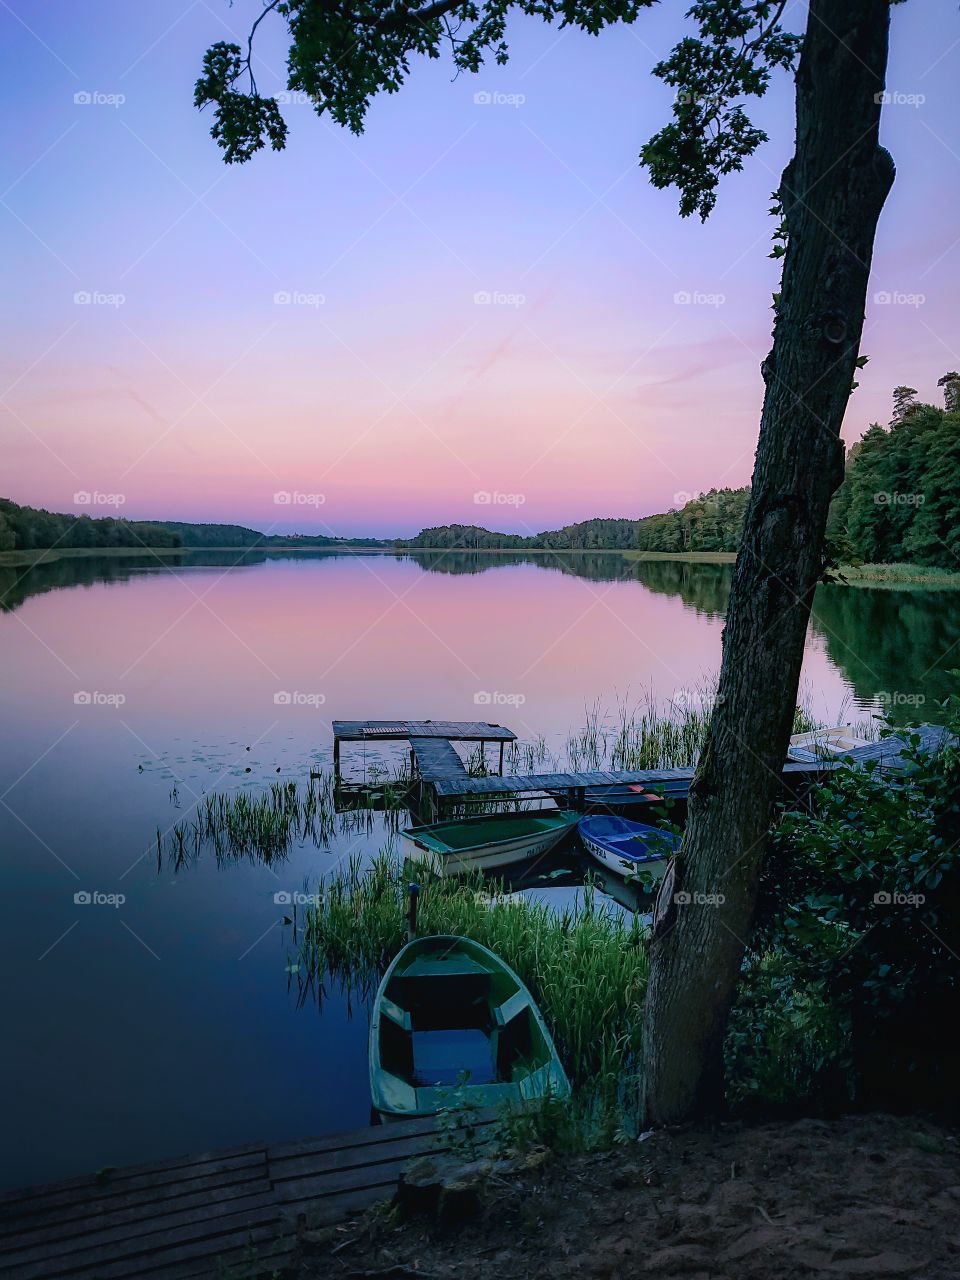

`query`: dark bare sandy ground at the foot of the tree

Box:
[296,1115,960,1280]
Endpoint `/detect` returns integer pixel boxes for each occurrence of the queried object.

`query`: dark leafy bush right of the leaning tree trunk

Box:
[726,717,960,1107]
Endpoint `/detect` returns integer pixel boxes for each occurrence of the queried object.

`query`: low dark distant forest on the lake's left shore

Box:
[0,498,390,552]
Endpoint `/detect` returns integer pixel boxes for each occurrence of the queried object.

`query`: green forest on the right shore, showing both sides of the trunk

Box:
[396,372,960,570]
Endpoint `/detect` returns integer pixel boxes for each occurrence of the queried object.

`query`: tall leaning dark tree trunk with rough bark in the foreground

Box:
[644,0,893,1124]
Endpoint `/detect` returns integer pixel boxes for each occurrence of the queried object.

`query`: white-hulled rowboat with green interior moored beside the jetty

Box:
[401,809,580,876]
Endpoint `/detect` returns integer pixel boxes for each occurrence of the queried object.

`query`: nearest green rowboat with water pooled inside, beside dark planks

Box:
[370,934,570,1119]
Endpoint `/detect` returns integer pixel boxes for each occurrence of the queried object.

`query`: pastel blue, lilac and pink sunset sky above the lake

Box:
[0,0,960,536]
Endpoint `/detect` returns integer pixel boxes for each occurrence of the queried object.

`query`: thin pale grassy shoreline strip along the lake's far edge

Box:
[0,544,960,590]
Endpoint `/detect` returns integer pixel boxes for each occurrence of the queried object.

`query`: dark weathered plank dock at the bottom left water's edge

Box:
[0,1119,473,1280]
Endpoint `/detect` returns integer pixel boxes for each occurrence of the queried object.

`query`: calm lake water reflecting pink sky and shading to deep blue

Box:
[0,553,960,1185]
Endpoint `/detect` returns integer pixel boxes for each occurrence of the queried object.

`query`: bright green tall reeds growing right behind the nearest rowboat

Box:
[298,850,649,1102]
